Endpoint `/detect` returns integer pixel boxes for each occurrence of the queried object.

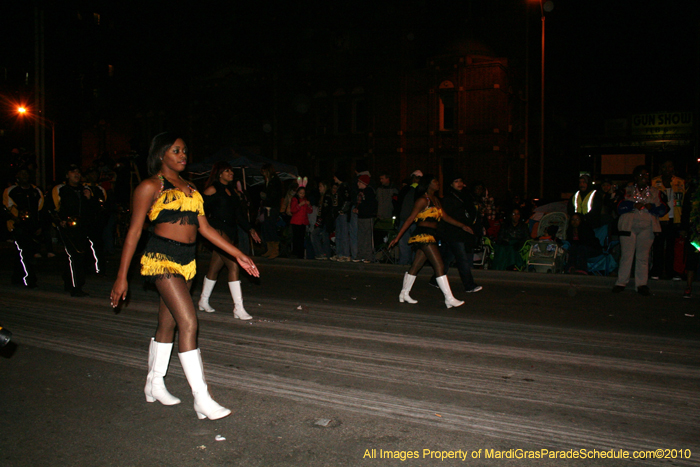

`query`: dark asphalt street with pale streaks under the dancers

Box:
[0,248,700,467]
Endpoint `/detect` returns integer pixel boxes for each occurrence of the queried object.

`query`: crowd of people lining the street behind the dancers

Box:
[3,144,700,297]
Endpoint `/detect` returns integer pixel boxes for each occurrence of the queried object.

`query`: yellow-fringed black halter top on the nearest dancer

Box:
[148,175,204,227]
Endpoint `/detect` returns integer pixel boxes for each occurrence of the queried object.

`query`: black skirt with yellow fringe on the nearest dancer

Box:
[141,234,197,281]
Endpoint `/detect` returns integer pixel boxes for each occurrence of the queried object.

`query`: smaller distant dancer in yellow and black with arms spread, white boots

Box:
[389,175,472,308]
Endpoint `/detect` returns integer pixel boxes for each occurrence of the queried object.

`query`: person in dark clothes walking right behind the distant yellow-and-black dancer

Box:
[430,174,483,293]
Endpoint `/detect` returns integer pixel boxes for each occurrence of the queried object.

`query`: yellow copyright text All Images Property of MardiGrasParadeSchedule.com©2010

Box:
[362,448,692,462]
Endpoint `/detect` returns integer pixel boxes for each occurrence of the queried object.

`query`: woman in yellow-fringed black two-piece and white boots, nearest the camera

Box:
[110,133,259,420]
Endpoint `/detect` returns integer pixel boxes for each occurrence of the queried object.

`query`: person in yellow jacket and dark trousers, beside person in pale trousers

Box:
[651,160,686,280]
